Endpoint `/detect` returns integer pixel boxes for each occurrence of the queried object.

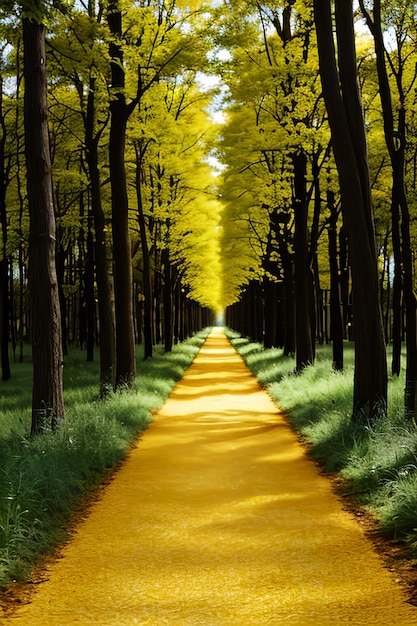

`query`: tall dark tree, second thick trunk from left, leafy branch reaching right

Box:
[107,0,208,385]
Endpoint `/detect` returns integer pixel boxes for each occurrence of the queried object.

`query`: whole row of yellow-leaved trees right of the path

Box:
[218,0,417,418]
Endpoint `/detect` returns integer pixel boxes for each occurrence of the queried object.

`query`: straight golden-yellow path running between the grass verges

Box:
[4,330,417,626]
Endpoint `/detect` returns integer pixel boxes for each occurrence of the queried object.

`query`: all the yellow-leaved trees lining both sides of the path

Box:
[0,0,417,433]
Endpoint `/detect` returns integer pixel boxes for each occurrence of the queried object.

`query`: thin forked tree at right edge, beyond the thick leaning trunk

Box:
[360,0,417,416]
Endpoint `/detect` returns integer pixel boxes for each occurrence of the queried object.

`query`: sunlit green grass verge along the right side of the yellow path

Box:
[226,329,417,557]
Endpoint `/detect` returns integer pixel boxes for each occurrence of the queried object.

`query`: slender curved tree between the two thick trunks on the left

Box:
[50,0,115,395]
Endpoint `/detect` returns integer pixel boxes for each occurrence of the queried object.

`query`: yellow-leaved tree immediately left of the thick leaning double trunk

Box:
[213,0,329,358]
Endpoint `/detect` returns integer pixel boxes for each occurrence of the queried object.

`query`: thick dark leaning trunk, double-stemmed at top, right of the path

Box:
[314,0,387,417]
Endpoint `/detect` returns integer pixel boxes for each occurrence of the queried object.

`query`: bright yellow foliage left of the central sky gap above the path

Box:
[127,71,226,312]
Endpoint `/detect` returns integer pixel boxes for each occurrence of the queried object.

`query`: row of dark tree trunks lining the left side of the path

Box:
[0,0,211,434]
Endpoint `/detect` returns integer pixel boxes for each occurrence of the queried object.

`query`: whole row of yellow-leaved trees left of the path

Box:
[0,2,219,426]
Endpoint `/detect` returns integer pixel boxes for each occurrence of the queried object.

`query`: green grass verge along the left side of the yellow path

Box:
[0,329,208,588]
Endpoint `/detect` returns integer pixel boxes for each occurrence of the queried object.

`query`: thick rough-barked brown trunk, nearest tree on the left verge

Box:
[23,18,64,434]
